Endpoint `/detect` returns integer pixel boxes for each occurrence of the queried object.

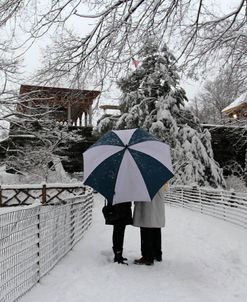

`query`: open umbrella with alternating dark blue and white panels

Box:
[83,128,173,204]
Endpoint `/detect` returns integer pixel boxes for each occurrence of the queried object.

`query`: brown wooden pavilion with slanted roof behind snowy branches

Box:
[17,85,100,126]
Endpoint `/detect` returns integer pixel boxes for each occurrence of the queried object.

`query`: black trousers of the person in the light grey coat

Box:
[140,228,162,260]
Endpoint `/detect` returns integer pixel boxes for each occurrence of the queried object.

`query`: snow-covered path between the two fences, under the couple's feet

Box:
[20,195,247,302]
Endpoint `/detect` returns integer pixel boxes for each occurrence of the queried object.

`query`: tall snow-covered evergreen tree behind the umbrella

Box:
[98,42,225,187]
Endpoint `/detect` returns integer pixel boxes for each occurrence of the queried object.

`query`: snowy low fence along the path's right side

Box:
[165,186,247,229]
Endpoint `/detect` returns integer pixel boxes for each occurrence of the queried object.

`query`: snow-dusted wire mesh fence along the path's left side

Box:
[0,186,93,302]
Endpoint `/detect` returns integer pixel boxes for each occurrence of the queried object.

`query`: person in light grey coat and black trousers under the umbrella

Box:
[133,184,167,265]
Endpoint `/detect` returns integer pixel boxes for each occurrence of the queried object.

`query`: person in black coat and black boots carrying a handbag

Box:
[103,202,133,264]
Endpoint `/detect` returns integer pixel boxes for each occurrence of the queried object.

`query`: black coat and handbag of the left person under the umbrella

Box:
[103,202,133,225]
